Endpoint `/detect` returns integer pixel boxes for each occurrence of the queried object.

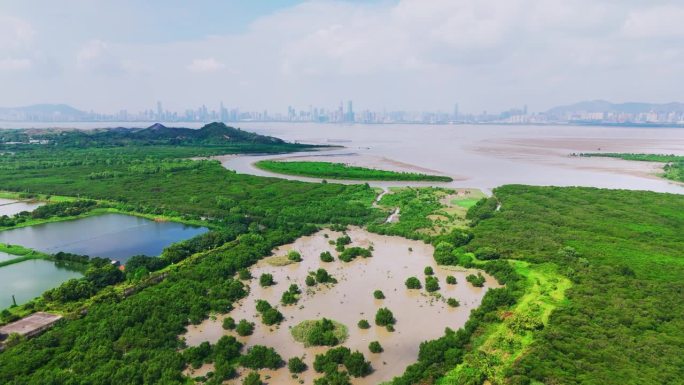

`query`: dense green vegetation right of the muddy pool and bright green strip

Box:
[452,186,684,384]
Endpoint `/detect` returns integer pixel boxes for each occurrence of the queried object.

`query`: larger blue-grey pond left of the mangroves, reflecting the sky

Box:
[0,214,208,263]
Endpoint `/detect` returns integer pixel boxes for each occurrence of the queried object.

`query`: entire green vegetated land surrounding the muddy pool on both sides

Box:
[0,124,684,385]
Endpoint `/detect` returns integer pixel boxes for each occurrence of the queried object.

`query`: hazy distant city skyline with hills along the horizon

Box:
[0,100,684,126]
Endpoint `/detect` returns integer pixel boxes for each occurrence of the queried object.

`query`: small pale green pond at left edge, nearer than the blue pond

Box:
[0,259,82,309]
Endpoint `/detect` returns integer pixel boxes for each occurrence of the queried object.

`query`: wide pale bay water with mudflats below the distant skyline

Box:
[223,123,684,194]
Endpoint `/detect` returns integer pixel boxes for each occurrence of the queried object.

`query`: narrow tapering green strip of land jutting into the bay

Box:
[254,160,453,182]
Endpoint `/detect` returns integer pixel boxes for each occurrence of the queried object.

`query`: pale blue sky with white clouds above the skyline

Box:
[0,0,684,113]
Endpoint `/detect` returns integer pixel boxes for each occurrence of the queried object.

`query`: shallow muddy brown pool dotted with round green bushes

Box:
[181,228,499,385]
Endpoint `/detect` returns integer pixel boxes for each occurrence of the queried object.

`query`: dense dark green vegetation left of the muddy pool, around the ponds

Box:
[0,127,382,384]
